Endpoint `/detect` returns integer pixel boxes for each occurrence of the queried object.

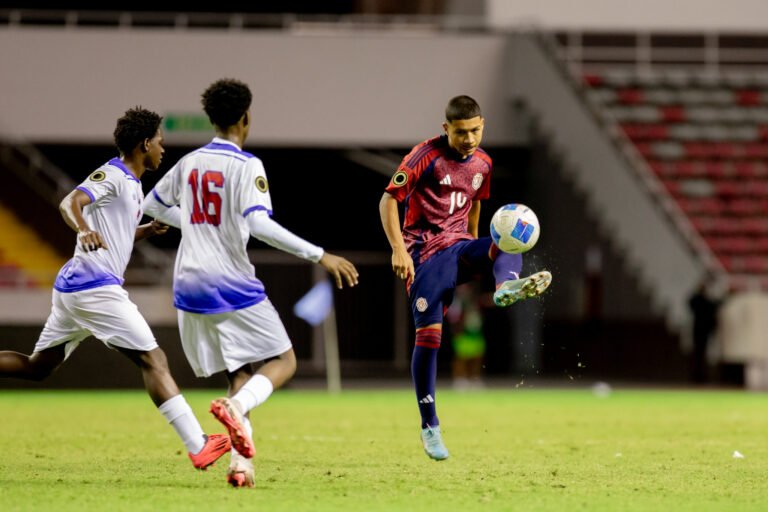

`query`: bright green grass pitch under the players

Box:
[0,389,768,512]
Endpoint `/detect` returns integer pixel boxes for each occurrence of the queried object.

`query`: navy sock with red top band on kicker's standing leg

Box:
[411,328,442,428]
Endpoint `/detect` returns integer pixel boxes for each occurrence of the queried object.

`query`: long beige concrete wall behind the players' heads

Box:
[0,26,515,147]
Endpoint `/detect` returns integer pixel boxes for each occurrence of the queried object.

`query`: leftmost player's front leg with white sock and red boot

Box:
[116,347,231,469]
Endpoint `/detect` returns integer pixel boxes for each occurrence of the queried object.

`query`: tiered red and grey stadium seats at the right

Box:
[568,34,768,289]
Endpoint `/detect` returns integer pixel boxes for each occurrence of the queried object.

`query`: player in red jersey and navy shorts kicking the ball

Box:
[379,96,552,460]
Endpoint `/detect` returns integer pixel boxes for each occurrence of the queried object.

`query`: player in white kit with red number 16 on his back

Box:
[144,79,358,487]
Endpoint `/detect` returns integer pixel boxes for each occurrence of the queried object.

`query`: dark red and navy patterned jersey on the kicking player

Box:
[386,135,491,264]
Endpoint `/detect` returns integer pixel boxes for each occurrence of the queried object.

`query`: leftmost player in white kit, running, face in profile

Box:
[0,107,231,469]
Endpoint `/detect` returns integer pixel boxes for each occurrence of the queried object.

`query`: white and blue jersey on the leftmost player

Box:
[53,158,144,293]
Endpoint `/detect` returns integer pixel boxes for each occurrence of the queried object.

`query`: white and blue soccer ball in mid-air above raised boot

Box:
[491,203,541,254]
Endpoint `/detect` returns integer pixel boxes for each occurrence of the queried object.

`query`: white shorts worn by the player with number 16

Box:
[178,299,292,377]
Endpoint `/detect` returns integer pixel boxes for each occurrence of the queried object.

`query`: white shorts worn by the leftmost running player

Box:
[35,284,158,357]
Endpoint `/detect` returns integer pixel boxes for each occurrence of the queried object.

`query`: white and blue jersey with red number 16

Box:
[151,137,272,314]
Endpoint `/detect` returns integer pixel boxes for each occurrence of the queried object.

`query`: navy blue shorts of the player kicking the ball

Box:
[408,237,493,328]
